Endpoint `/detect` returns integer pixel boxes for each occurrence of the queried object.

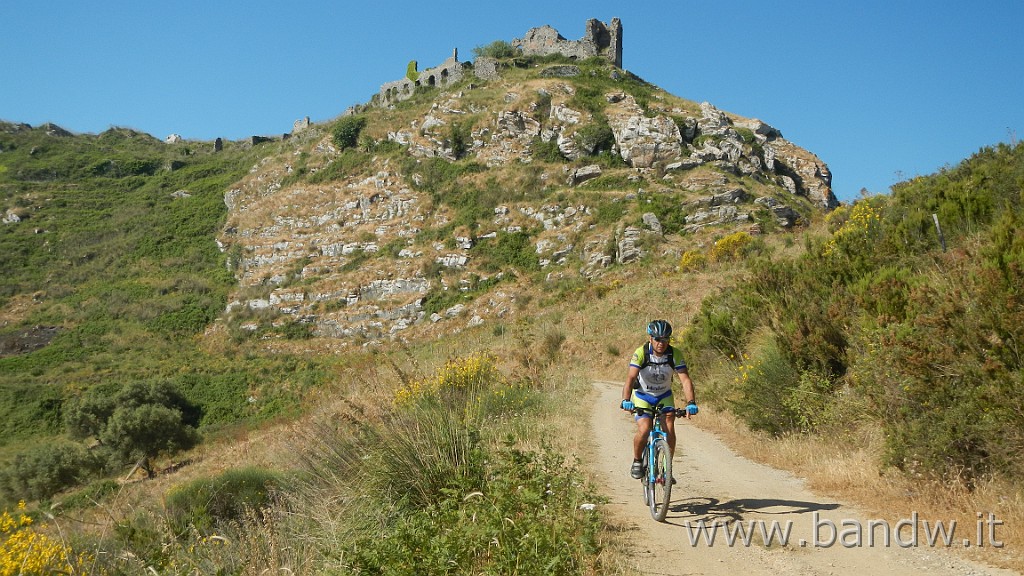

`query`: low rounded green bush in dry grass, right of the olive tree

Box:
[164,467,284,535]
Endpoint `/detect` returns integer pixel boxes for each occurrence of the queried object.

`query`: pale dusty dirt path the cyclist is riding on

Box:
[588,382,1017,576]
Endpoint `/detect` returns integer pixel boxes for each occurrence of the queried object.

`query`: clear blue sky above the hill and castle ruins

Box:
[0,0,1024,200]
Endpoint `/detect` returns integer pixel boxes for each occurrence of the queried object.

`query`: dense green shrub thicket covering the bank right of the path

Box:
[685,145,1024,483]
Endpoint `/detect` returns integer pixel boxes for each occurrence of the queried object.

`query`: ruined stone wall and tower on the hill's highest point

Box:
[512,18,623,68]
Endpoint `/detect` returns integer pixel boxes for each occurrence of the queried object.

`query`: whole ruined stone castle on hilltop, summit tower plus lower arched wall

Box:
[374,18,623,107]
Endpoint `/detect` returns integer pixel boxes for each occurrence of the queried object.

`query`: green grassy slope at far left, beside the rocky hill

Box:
[0,127,333,454]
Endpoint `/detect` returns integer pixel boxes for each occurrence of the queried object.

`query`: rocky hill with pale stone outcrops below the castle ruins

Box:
[219,42,837,346]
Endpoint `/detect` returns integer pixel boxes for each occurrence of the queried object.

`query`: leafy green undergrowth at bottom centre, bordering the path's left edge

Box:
[344,438,601,575]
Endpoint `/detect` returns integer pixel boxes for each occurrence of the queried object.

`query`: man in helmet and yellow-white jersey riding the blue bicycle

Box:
[621,320,697,479]
